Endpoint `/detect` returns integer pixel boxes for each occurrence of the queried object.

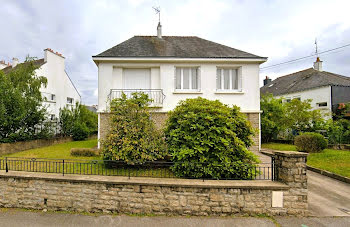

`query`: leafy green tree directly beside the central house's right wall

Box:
[260,94,287,143]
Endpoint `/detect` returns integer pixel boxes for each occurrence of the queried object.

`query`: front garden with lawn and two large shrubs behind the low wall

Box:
[0,93,272,179]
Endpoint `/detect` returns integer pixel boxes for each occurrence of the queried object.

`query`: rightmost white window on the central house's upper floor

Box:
[216,68,242,91]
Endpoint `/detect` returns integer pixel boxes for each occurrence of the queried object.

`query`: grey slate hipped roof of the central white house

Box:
[94,36,266,59]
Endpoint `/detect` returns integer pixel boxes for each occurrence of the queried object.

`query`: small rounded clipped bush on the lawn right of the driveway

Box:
[294,132,328,153]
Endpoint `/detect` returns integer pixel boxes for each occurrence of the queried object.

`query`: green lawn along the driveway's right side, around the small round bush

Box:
[262,143,350,177]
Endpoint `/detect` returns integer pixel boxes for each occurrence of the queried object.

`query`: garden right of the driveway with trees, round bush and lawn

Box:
[261,95,350,177]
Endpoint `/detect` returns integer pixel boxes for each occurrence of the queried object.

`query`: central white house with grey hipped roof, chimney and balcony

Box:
[93,25,267,149]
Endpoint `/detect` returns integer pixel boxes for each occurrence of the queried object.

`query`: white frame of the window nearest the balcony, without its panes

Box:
[174,66,201,92]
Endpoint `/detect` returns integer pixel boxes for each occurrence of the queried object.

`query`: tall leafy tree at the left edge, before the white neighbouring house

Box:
[0,57,47,142]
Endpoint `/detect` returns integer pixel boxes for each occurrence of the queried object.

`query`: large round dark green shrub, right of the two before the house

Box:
[165,97,258,179]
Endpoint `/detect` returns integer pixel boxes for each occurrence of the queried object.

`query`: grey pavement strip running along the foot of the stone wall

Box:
[0,209,350,227]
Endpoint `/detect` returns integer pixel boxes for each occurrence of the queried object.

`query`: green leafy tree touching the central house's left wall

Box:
[59,102,98,140]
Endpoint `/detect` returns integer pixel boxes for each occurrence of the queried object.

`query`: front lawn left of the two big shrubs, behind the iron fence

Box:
[0,139,175,177]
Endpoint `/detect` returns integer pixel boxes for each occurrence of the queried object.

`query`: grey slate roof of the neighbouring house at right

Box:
[260,68,350,96]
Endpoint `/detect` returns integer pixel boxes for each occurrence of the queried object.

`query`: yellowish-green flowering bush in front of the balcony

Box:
[102,93,167,164]
